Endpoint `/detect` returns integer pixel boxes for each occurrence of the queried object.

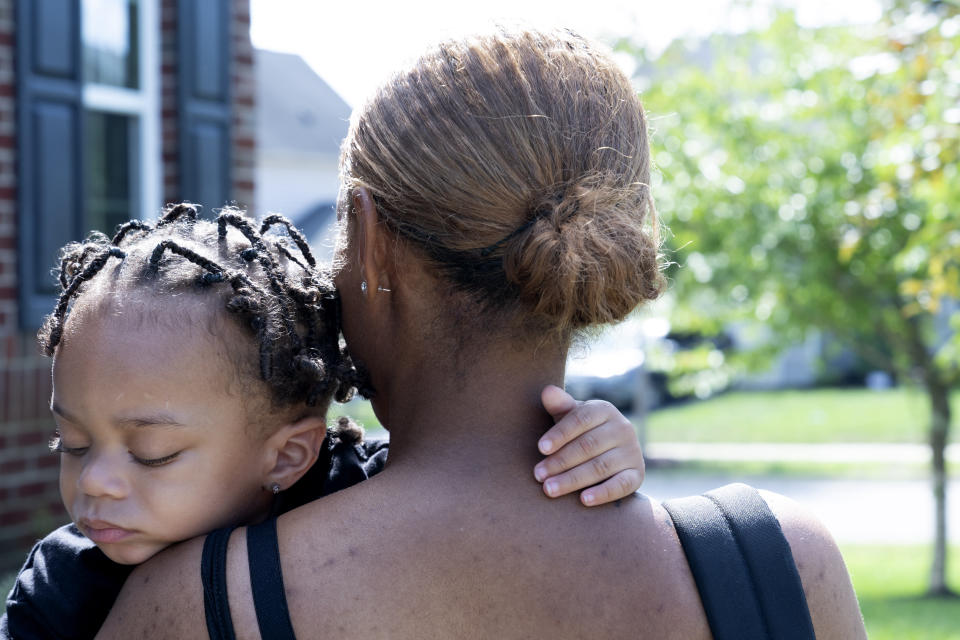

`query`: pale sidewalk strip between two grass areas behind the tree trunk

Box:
[643,442,960,464]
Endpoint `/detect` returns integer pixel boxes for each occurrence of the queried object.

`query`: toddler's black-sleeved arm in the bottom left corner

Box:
[0,525,133,640]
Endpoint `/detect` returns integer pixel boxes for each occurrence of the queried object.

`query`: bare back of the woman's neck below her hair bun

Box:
[383,343,566,477]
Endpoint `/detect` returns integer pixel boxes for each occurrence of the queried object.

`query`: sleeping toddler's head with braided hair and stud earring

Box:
[39,205,355,564]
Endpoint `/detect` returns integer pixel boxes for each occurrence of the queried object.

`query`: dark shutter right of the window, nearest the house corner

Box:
[177,0,232,214]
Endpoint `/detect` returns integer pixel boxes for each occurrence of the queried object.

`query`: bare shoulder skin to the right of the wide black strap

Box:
[760,490,867,640]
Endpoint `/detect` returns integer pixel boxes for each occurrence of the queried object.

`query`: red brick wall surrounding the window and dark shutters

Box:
[0,0,255,568]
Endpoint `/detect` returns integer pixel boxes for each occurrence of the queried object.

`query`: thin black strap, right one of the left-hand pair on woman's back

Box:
[247,518,295,640]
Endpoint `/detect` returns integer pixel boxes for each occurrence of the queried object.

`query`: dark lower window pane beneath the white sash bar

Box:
[84,111,140,235]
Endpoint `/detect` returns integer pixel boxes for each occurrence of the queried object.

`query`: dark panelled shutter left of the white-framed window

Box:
[15,0,83,329]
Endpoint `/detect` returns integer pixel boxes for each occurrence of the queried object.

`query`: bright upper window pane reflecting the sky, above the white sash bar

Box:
[82,0,139,89]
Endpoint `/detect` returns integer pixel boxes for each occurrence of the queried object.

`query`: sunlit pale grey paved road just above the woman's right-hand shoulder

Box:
[640,469,960,544]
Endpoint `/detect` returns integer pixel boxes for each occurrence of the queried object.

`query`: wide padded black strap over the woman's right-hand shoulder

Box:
[663,483,815,640]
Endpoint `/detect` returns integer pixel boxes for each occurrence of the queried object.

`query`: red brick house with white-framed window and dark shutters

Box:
[0,0,256,570]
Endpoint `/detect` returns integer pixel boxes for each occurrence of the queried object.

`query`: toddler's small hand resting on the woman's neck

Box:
[534,385,644,507]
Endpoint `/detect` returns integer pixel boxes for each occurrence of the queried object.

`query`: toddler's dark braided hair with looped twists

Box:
[38,203,372,416]
